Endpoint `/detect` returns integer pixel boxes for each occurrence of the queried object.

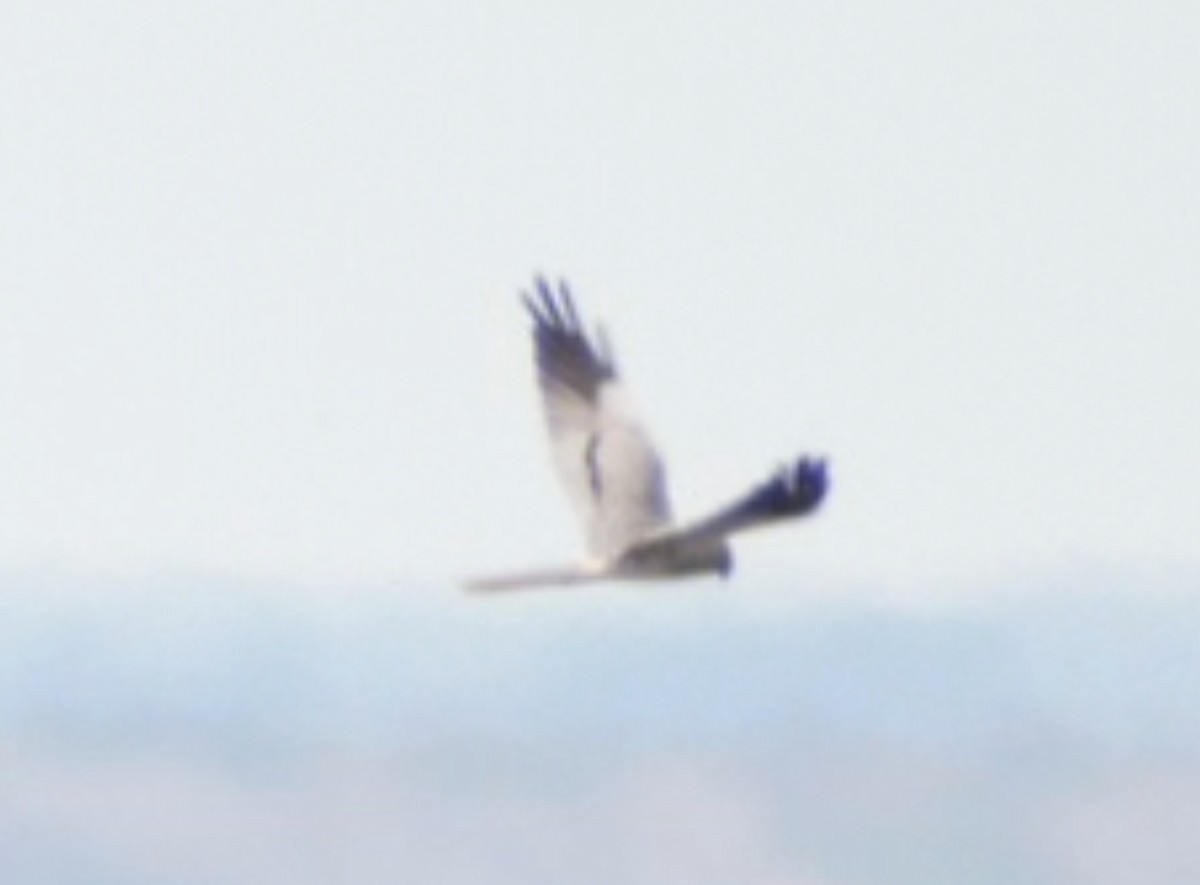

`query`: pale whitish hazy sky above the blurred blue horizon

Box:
[0,0,1200,592]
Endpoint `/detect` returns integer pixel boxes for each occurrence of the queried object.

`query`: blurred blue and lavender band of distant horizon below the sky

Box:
[0,570,1200,885]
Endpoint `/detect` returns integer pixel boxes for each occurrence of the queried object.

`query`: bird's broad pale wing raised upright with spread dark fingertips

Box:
[524,279,671,558]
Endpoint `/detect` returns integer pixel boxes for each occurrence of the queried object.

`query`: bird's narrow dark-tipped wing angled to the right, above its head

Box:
[637,458,829,549]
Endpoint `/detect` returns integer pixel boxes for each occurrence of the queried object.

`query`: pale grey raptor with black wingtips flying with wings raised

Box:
[466,278,829,591]
